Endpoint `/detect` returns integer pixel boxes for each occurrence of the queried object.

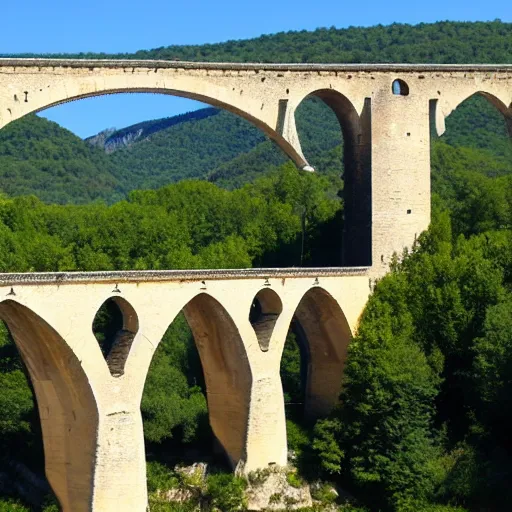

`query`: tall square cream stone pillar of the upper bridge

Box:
[371,87,430,277]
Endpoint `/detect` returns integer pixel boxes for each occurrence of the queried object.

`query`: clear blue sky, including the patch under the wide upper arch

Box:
[0,0,512,137]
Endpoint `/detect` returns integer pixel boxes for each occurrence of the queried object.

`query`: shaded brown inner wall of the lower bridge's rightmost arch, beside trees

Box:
[294,287,352,419]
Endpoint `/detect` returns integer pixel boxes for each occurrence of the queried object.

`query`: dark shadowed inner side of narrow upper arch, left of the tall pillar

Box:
[296,89,372,266]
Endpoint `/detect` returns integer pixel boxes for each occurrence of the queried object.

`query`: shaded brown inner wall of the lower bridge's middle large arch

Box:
[178,293,252,468]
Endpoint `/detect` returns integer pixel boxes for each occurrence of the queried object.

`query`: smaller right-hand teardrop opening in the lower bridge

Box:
[249,288,283,352]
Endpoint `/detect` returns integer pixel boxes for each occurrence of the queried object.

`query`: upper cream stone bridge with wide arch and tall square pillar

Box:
[0,59,512,276]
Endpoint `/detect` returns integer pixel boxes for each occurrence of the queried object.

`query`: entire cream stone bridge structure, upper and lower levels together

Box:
[0,59,512,512]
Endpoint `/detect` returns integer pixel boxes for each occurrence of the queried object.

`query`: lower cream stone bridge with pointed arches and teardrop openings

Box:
[0,268,371,512]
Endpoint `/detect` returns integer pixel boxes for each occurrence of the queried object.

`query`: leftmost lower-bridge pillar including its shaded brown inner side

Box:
[0,300,147,512]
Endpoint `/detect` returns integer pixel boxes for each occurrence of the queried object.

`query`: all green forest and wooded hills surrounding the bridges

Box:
[0,21,512,512]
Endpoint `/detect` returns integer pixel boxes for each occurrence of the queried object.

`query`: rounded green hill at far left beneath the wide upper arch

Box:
[0,115,124,203]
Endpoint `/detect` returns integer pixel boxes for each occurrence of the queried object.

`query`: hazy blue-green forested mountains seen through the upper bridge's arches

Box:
[0,96,512,204]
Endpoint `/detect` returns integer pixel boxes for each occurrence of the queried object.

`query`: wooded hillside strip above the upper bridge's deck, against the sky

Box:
[3,20,512,64]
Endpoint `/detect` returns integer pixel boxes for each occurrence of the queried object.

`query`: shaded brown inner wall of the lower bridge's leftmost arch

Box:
[0,300,98,512]
